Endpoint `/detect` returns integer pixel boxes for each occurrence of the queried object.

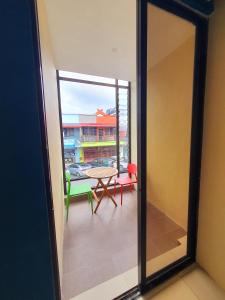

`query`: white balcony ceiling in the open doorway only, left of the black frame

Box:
[45,0,136,80]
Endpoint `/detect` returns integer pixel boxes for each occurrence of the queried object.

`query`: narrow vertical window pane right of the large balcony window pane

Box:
[119,88,129,172]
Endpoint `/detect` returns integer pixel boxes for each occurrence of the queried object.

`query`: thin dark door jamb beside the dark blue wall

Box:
[27,0,61,300]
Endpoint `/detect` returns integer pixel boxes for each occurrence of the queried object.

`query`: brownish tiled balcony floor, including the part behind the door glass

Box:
[62,192,185,300]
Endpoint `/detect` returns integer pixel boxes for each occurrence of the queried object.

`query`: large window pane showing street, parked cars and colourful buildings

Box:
[60,81,116,179]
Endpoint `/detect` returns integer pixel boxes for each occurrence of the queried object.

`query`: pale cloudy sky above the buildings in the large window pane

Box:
[60,81,115,114]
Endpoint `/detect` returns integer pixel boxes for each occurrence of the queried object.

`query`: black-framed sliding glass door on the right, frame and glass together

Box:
[138,0,207,290]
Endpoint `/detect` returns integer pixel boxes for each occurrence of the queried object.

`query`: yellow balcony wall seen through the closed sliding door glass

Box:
[147,37,195,231]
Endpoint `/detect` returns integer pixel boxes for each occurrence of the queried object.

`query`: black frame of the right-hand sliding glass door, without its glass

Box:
[137,0,208,293]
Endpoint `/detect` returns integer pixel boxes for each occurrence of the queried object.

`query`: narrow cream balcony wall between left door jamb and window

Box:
[38,0,64,282]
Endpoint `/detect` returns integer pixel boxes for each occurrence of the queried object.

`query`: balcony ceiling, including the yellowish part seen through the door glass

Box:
[45,0,194,81]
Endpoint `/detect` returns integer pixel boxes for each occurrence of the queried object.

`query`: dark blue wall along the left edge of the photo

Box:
[0,0,59,300]
